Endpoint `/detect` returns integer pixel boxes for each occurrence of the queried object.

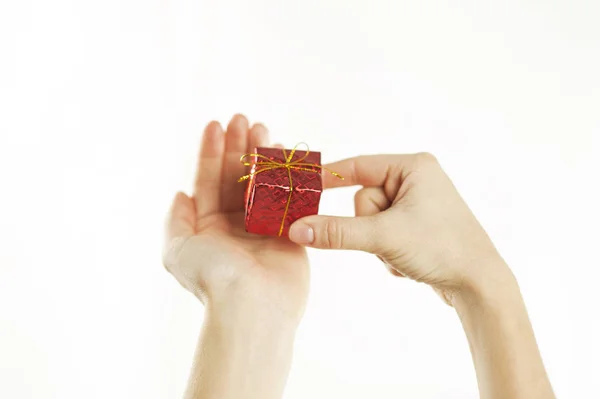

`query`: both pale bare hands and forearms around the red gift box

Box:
[164,115,554,399]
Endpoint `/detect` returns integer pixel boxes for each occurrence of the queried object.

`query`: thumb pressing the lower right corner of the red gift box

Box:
[288,215,377,252]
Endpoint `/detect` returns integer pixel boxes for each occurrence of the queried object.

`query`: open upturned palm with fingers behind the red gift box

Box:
[163,115,309,323]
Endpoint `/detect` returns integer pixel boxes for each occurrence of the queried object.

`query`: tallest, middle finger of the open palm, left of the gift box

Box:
[221,114,249,212]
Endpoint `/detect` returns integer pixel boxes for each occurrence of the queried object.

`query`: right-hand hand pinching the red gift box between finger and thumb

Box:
[289,154,511,304]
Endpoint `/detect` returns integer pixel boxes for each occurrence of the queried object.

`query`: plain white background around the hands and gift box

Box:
[0,0,600,399]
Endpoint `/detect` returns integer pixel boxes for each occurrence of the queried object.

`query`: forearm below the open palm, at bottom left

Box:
[185,307,296,399]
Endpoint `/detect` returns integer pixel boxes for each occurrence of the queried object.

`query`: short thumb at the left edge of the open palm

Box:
[163,192,196,269]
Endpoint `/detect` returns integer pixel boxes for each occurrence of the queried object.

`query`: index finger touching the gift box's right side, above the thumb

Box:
[323,154,409,189]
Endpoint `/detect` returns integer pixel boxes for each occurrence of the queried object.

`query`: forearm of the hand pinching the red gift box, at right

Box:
[454,261,554,399]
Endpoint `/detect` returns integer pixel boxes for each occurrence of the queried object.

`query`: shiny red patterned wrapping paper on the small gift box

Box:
[245,147,323,236]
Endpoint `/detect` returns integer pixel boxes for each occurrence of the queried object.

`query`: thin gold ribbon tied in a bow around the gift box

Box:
[238,143,344,236]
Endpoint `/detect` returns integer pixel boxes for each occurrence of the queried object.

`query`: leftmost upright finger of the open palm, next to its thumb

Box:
[194,122,225,218]
